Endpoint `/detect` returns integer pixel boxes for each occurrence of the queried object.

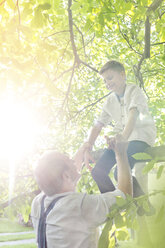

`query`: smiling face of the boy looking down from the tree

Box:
[102,69,126,94]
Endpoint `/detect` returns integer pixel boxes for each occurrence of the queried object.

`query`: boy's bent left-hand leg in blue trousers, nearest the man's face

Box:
[91,149,116,193]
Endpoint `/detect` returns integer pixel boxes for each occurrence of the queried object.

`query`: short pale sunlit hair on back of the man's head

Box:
[34,151,71,196]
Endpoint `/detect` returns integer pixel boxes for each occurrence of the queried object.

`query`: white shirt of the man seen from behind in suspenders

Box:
[31,190,125,248]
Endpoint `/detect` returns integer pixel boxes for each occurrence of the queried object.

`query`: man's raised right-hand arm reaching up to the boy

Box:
[115,135,133,196]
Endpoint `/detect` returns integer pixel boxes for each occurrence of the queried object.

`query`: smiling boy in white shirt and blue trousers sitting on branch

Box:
[84,60,156,197]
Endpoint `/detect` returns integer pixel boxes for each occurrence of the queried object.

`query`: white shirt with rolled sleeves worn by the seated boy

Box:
[98,84,156,146]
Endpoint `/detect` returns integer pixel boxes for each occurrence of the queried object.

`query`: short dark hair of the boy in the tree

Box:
[99,60,125,75]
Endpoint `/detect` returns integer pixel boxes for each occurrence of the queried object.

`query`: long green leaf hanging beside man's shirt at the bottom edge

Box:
[98,220,112,248]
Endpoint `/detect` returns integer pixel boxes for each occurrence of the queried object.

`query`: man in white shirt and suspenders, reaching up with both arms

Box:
[31,135,132,248]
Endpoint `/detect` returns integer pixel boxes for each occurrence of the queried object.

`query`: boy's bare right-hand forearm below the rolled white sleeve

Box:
[122,107,139,140]
